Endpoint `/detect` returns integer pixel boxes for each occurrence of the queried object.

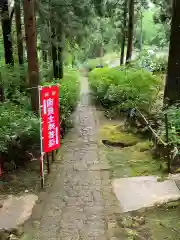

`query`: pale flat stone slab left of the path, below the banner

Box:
[0,194,38,230]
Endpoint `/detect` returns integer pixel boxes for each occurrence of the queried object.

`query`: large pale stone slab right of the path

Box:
[112,176,180,212]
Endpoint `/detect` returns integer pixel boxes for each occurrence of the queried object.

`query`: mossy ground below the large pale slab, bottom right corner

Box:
[114,201,180,240]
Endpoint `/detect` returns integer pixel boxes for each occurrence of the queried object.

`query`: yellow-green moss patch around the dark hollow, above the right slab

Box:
[100,125,164,178]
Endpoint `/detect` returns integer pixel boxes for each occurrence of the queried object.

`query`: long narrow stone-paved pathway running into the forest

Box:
[24,78,116,240]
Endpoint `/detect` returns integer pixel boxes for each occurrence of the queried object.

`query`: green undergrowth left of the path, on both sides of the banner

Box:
[0,63,79,167]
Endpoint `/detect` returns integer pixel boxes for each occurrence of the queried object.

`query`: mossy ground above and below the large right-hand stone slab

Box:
[99,121,180,240]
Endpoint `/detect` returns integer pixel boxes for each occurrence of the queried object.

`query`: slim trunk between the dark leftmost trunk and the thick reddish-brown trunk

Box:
[15,0,24,65]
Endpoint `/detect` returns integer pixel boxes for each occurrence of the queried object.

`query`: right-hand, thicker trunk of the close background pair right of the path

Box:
[126,0,134,64]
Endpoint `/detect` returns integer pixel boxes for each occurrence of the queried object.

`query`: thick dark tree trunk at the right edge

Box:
[164,0,180,104]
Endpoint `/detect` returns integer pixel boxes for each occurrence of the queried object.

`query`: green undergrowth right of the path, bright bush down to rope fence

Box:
[89,51,180,172]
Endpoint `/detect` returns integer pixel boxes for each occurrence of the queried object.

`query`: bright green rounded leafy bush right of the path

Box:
[89,68,162,116]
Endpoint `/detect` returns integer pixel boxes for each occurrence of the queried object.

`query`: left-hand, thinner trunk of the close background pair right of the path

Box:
[120,0,127,65]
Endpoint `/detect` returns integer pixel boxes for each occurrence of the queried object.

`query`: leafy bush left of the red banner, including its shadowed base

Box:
[0,102,40,167]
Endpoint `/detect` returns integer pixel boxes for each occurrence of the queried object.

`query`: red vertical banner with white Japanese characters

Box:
[39,86,60,153]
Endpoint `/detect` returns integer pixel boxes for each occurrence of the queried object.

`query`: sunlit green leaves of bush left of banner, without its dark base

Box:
[0,102,39,153]
